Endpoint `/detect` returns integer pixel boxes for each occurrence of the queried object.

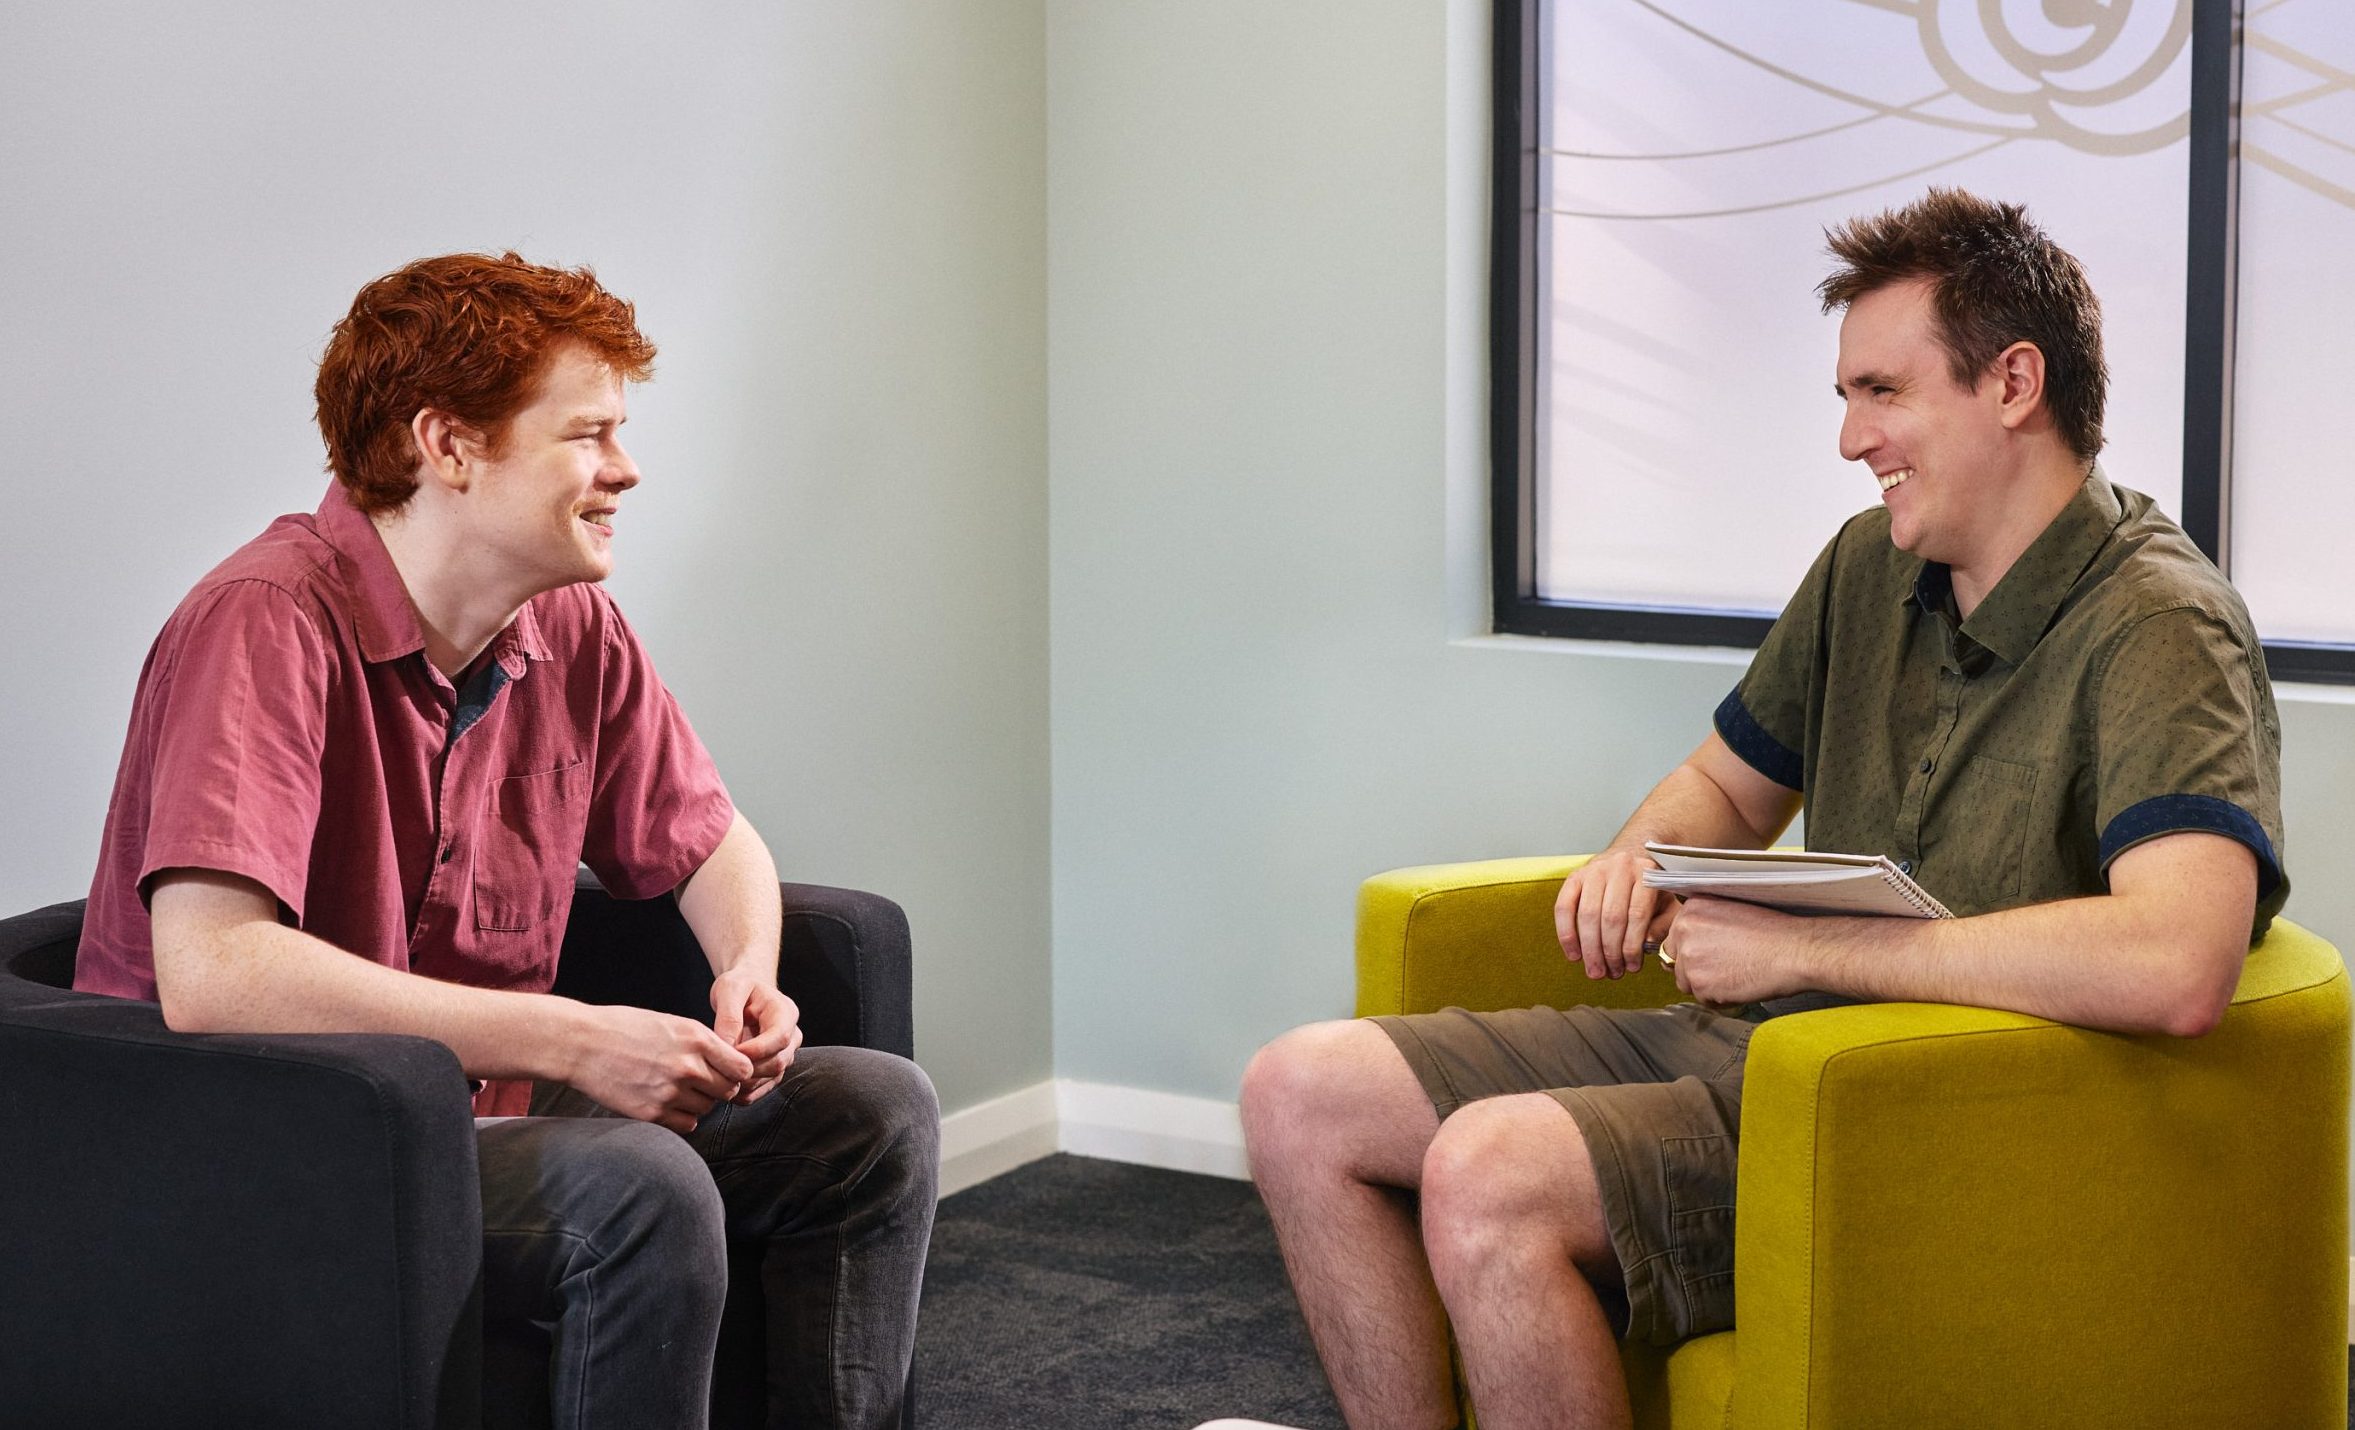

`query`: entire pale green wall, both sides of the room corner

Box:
[0,0,2355,1163]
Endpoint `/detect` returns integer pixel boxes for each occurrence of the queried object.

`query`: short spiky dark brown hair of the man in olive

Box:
[1816,188,2110,462]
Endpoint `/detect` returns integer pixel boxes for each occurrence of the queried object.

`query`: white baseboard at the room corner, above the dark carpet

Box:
[940,1077,1251,1197]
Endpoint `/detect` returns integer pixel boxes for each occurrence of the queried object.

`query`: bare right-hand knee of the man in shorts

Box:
[1422,1093,1611,1289]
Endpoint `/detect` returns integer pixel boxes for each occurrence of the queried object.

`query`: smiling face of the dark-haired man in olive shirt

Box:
[1837,283,2011,568]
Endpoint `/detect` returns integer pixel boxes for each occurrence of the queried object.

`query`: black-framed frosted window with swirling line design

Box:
[1491,0,2355,681]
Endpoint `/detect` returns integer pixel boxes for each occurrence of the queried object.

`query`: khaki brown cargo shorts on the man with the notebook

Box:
[1373,1004,1757,1345]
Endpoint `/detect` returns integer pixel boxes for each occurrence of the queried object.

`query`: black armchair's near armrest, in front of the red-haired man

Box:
[0,975,483,1428]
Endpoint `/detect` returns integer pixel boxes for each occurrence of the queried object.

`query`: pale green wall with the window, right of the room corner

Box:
[1048,0,2355,1130]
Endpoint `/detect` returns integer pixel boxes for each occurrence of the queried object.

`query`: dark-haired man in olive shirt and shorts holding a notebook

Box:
[1243,191,2289,1430]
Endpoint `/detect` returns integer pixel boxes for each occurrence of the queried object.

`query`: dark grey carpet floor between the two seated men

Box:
[916,1157,1340,1430]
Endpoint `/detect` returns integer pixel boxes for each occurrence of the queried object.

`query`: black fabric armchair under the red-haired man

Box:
[0,874,914,1430]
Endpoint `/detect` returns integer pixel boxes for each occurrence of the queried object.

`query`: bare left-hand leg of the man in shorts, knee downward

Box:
[1243,1022,1455,1430]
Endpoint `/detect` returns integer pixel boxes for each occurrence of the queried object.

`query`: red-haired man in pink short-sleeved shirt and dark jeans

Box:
[75,254,940,1430]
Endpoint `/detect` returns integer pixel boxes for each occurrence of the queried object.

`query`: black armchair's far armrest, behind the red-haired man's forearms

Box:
[556,869,916,1058]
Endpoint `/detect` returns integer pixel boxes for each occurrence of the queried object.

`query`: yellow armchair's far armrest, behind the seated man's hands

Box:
[1356,855,1684,1018]
